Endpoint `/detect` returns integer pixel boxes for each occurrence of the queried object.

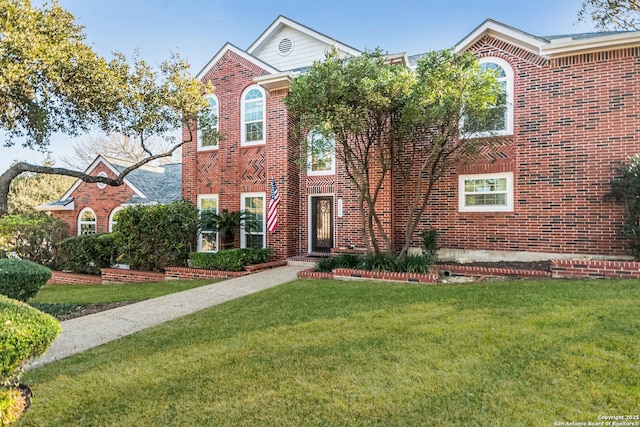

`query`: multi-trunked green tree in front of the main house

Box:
[286,49,505,258]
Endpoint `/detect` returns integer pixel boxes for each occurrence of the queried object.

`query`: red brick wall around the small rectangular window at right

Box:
[395,37,640,255]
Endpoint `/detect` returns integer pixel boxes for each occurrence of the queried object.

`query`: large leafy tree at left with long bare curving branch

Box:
[0,0,217,215]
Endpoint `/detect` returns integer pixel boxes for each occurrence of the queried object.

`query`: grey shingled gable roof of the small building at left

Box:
[36,155,182,210]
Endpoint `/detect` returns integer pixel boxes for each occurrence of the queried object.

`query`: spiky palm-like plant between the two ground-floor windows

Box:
[200,209,259,249]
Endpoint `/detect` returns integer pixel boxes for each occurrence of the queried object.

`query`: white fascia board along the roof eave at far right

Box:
[541,31,640,58]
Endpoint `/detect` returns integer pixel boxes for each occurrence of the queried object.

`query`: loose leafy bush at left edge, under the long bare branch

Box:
[0,214,69,269]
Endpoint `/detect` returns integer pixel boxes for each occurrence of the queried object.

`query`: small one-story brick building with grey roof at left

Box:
[36,156,182,235]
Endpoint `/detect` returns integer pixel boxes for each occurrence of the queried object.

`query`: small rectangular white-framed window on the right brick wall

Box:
[458,172,513,212]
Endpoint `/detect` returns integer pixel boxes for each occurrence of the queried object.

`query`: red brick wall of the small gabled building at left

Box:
[52,163,135,236]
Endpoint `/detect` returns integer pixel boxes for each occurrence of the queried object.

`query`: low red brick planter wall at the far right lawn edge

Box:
[551,259,640,279]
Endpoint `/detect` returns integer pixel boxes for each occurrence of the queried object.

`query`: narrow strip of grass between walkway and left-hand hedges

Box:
[29,279,216,316]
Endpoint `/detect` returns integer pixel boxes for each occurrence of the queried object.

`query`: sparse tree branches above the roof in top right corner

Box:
[578,0,640,30]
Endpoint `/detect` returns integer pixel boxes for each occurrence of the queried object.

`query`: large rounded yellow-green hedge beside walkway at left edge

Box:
[0,295,62,384]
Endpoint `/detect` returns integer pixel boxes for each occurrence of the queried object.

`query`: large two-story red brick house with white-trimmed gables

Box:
[182,16,640,260]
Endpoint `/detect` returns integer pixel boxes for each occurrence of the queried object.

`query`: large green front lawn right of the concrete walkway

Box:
[19,280,640,426]
